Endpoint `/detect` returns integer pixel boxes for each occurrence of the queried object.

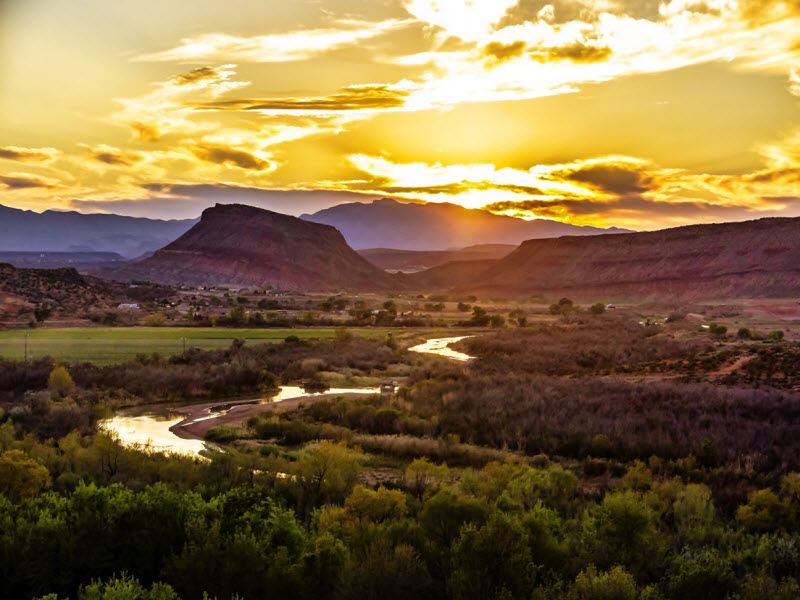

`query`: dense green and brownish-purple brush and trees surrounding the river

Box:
[0,311,800,600]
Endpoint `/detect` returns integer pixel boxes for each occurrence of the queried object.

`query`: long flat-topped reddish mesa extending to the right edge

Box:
[409,218,800,299]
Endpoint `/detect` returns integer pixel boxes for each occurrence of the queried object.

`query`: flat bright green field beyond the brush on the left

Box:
[0,327,398,364]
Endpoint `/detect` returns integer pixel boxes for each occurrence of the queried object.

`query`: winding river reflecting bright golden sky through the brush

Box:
[99,336,473,456]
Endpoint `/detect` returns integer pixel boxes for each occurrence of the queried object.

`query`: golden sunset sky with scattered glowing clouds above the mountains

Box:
[0,0,800,230]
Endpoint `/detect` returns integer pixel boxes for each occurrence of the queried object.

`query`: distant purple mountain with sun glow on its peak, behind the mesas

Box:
[300,198,625,250]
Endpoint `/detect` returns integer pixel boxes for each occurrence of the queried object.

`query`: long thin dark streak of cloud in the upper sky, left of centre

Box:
[195,85,408,111]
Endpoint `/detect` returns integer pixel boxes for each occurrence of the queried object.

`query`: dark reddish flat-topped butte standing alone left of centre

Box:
[104,204,394,291]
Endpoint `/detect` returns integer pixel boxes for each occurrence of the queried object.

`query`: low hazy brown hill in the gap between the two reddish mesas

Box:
[358,244,517,273]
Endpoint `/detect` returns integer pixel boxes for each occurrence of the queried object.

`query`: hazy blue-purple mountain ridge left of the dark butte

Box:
[0,205,196,258]
